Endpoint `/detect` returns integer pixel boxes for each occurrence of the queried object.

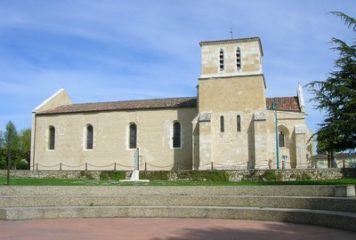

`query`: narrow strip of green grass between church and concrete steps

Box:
[0,176,356,186]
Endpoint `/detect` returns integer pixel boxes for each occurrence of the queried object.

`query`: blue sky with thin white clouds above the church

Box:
[0,0,356,131]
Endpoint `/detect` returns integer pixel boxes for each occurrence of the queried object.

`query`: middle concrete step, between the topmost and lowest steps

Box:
[0,194,356,213]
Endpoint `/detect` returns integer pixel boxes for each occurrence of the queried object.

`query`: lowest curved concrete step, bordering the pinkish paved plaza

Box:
[0,206,356,231]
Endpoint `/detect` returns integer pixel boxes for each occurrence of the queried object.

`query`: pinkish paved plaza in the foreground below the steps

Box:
[0,218,356,240]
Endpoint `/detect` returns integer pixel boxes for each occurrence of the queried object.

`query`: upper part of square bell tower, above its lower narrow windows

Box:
[199,37,266,112]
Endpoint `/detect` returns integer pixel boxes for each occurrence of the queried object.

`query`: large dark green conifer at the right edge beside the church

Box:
[309,12,356,167]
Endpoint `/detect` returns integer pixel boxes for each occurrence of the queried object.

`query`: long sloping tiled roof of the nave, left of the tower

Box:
[38,97,196,114]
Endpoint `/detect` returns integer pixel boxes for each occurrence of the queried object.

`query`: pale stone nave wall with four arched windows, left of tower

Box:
[31,108,197,170]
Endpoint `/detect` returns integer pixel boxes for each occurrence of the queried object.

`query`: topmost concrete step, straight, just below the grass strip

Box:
[0,186,335,197]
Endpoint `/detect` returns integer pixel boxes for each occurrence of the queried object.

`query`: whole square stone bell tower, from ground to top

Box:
[193,37,266,169]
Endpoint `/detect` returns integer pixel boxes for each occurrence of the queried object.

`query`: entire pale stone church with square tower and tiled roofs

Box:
[31,37,311,170]
